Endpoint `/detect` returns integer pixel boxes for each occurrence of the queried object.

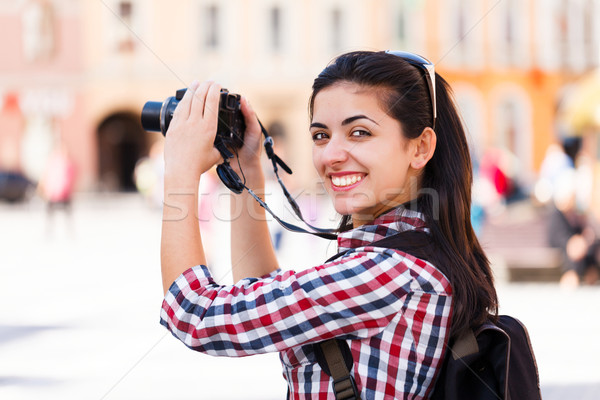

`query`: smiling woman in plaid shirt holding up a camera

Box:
[161,52,497,399]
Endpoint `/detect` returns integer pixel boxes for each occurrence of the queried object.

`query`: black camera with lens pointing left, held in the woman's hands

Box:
[142,89,246,149]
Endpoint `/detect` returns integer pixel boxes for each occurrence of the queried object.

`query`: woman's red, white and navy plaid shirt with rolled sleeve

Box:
[160,208,452,400]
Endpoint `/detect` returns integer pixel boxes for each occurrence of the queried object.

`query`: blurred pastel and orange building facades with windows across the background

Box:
[0,0,600,191]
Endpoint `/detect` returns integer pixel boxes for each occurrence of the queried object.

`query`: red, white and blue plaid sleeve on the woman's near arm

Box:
[161,252,449,356]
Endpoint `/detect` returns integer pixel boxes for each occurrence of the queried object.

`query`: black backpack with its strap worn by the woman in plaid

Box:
[313,231,541,400]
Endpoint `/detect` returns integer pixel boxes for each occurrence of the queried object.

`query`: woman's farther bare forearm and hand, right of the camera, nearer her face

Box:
[230,98,278,282]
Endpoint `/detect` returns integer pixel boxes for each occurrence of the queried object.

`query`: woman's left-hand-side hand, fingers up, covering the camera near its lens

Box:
[165,81,221,183]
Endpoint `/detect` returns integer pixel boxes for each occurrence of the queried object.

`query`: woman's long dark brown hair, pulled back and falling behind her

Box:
[309,51,498,336]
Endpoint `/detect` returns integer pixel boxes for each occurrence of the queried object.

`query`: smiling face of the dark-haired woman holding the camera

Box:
[310,82,417,227]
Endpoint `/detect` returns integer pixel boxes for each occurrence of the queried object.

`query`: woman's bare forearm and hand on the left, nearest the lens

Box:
[161,82,221,293]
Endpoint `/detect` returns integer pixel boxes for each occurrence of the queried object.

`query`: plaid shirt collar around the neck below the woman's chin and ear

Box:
[337,206,429,252]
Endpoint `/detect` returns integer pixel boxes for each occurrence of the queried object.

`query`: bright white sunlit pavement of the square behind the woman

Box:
[0,195,600,400]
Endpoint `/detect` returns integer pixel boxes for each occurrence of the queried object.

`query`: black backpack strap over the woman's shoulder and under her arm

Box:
[313,231,433,400]
